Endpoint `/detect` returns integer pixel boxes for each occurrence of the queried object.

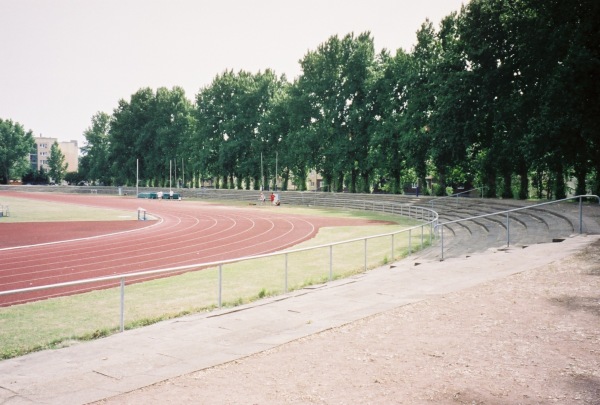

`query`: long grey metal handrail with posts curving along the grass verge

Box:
[0,202,439,332]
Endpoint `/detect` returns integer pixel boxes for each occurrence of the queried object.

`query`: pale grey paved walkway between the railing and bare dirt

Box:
[0,235,600,405]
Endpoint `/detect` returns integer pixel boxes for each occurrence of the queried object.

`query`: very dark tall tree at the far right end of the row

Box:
[524,0,600,198]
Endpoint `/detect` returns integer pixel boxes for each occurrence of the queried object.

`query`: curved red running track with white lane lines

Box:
[0,192,382,306]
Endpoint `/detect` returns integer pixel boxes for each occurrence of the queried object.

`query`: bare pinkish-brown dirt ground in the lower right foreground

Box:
[101,241,600,404]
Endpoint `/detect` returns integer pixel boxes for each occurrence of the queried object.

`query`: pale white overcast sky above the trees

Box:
[0,0,468,147]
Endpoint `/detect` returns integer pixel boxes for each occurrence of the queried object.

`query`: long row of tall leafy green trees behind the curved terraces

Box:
[2,0,600,198]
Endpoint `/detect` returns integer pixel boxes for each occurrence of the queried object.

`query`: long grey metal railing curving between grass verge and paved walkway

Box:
[0,202,438,332]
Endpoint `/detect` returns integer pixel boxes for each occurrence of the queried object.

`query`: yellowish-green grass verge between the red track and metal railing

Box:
[0,197,429,359]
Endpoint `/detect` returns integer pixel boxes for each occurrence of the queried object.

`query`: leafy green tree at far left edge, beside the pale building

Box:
[0,118,35,184]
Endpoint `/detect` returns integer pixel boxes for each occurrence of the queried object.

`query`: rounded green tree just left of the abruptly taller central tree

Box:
[193,70,285,188]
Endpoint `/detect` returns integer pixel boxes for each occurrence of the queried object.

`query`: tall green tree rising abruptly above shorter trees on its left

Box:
[297,32,374,191]
